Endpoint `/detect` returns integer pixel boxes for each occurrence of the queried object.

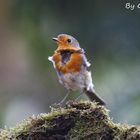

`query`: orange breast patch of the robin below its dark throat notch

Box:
[53,52,82,74]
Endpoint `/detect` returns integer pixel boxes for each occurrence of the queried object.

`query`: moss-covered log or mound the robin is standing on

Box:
[0,101,140,140]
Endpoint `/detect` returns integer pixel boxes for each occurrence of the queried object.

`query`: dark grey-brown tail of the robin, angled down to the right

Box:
[85,90,106,106]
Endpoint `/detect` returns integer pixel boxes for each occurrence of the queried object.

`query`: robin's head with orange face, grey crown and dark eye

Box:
[52,34,81,51]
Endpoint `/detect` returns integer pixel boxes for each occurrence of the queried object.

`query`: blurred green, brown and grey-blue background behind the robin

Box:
[0,0,140,127]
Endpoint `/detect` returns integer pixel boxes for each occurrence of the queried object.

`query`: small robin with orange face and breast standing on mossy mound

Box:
[48,34,105,105]
